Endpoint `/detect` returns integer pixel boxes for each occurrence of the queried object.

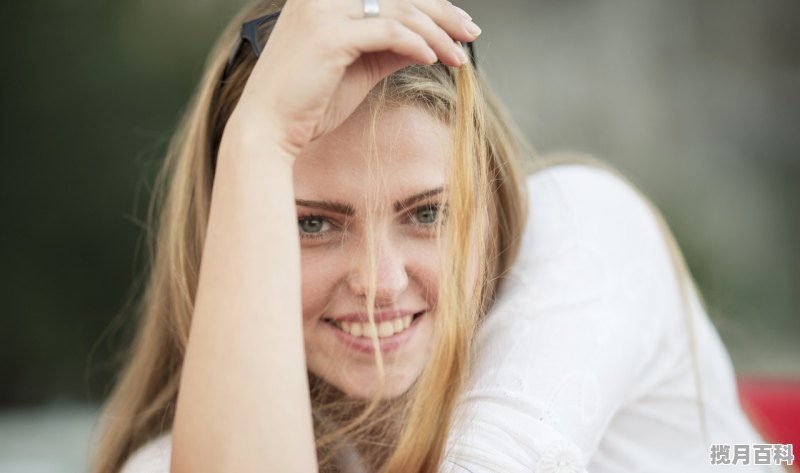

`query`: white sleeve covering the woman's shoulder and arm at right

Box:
[443,164,680,473]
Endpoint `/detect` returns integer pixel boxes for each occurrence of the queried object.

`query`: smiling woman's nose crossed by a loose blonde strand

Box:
[347,238,408,306]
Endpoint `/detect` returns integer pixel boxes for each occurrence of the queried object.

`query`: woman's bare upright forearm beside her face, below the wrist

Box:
[172,117,316,473]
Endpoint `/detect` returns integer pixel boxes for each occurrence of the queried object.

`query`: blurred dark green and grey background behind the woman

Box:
[0,0,800,472]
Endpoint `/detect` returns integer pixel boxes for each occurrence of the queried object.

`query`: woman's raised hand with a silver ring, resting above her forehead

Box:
[232,0,480,159]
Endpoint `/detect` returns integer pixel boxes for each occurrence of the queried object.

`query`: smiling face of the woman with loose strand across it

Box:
[294,104,451,399]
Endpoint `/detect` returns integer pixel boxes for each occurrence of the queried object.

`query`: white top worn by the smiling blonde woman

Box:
[115,164,782,473]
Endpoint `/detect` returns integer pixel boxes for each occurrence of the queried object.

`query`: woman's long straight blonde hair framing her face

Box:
[92,1,708,473]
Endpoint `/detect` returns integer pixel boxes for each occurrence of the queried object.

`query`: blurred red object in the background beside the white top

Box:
[738,377,800,471]
